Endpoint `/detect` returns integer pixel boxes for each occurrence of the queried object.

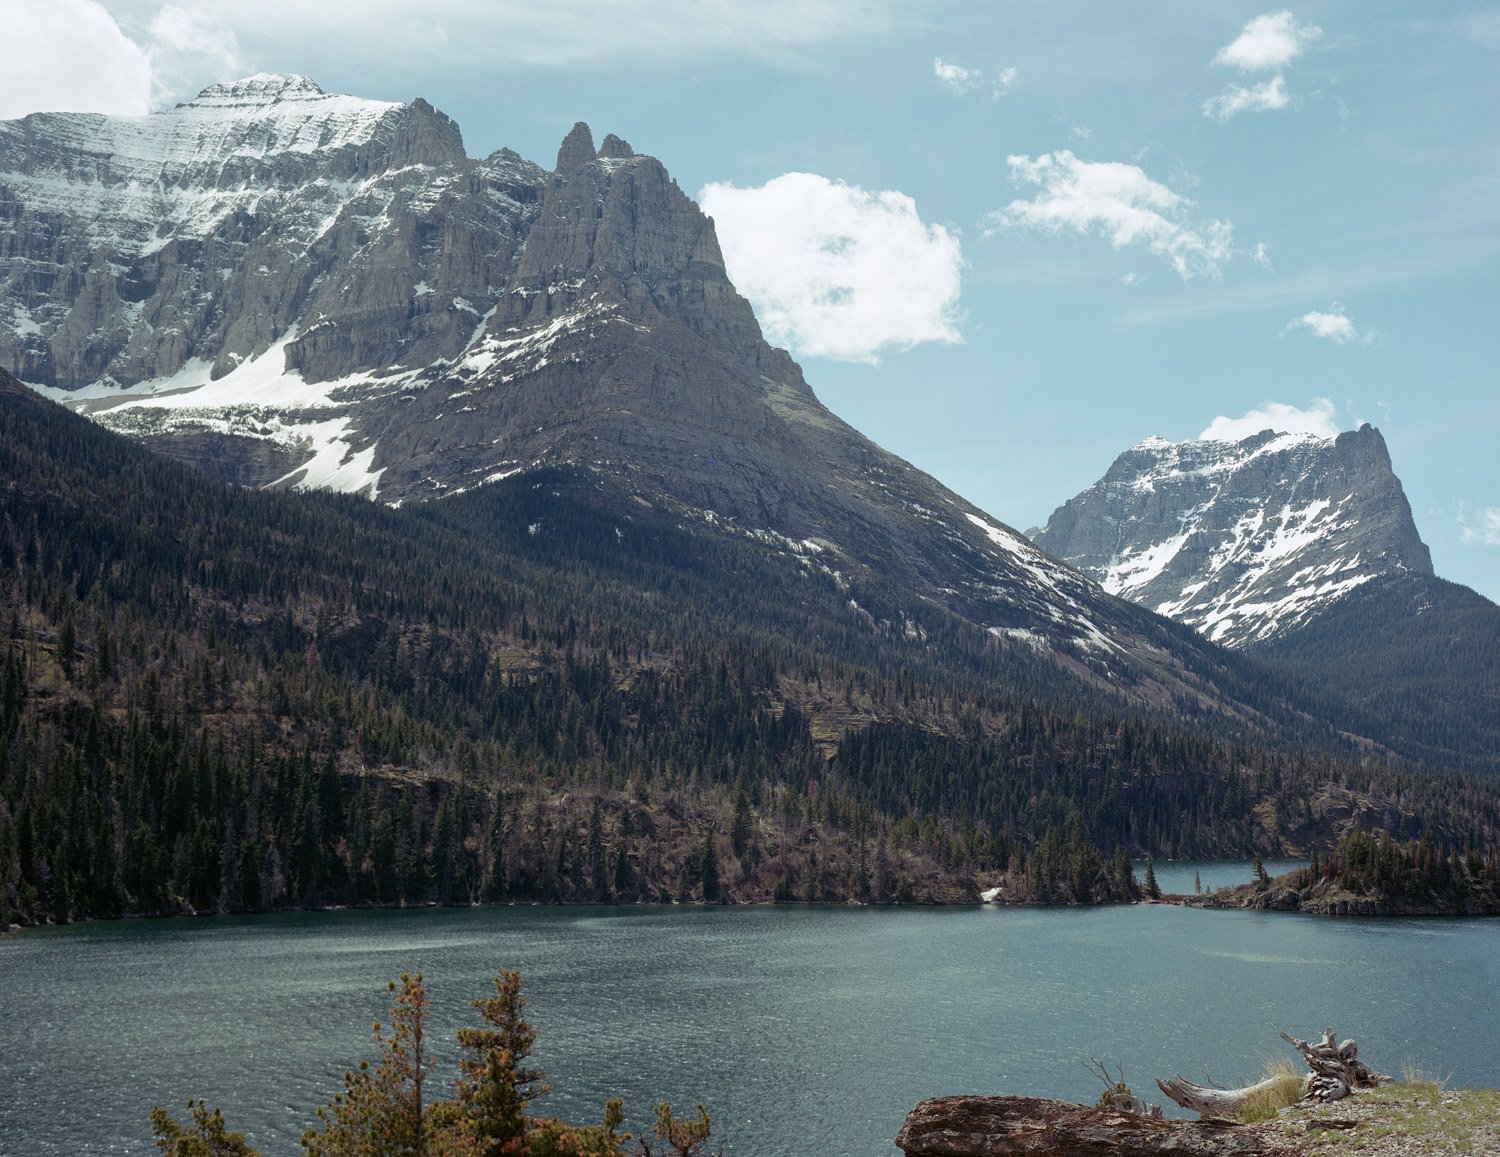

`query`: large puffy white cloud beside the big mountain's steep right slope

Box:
[699,173,963,362]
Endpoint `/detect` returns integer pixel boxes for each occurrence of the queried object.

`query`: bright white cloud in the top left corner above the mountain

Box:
[0,0,152,120]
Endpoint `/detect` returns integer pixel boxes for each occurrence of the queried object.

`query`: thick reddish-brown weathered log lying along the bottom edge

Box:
[896,1097,1286,1157]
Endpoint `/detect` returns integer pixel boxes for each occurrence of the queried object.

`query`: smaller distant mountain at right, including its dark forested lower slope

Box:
[1032,425,1500,770]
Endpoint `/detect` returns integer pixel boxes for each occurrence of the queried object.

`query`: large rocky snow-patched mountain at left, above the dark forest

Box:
[0,75,1326,711]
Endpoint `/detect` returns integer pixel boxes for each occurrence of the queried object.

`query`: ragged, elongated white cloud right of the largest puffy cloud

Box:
[986,149,1235,279]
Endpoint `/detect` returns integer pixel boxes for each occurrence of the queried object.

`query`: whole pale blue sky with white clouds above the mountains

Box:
[0,0,1500,600]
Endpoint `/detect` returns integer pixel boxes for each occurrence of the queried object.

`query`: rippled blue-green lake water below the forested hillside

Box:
[0,863,1500,1157]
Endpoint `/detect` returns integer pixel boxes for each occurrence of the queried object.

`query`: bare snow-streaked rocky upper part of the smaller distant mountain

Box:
[1032,425,1433,647]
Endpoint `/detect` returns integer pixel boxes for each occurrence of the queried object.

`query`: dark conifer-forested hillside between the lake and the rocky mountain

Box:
[0,381,1500,924]
